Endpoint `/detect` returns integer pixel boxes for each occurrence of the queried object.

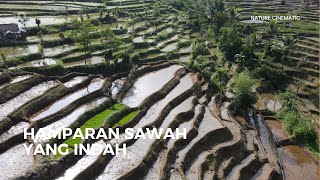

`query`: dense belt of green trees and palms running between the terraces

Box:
[171,0,319,154]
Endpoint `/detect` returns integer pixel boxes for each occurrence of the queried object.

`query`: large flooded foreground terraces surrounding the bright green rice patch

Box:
[0,62,277,179]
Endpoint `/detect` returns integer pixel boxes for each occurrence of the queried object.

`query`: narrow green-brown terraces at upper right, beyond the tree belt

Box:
[232,1,320,119]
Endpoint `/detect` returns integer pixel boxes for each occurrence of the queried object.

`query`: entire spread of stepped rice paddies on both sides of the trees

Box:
[0,0,319,180]
